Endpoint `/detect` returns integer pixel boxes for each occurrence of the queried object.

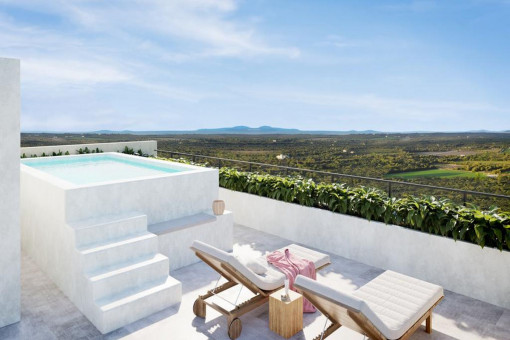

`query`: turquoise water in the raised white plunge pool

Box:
[21,154,186,185]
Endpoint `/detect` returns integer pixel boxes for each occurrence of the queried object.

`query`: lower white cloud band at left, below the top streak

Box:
[0,7,225,101]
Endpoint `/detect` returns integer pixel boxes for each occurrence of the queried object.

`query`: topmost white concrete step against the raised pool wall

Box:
[70,213,147,248]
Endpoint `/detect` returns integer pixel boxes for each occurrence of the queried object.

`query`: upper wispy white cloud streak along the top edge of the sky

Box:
[0,0,300,58]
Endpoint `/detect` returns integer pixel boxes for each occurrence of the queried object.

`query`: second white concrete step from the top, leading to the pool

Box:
[80,232,158,273]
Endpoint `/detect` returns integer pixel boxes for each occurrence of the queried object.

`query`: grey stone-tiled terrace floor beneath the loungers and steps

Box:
[0,226,510,340]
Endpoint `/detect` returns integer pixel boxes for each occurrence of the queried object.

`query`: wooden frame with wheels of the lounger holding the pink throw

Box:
[191,248,330,340]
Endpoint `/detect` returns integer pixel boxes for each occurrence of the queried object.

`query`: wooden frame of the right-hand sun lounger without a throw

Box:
[296,286,444,340]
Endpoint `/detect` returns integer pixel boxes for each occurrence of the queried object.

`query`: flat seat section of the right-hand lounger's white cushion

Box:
[353,270,443,339]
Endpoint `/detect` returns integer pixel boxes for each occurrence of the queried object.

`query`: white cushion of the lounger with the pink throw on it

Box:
[191,241,329,290]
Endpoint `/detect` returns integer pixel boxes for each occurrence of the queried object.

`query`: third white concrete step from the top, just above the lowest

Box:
[89,253,170,300]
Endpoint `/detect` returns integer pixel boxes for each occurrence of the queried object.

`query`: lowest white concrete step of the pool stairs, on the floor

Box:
[96,276,182,334]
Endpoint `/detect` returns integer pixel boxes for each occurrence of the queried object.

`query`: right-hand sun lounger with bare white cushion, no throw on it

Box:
[294,270,443,340]
